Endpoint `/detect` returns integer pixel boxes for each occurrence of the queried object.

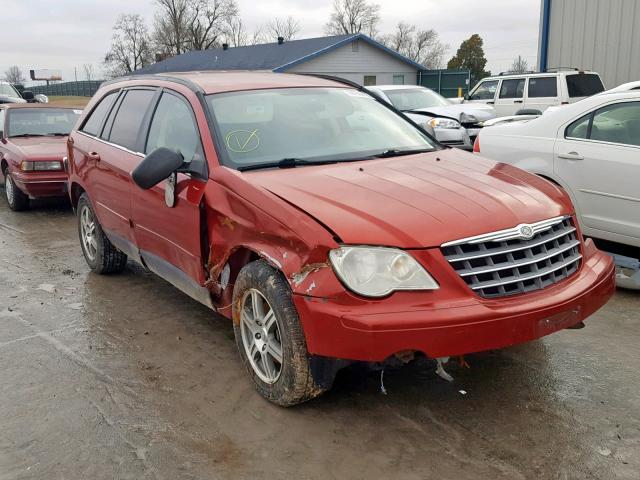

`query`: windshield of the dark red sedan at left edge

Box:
[8,108,82,137]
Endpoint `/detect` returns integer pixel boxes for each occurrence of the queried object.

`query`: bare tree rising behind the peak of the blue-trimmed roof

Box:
[324,0,380,37]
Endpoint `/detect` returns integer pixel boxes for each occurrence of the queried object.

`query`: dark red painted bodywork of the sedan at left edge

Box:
[0,104,77,198]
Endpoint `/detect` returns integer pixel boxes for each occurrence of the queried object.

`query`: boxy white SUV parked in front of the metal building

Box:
[463,70,604,117]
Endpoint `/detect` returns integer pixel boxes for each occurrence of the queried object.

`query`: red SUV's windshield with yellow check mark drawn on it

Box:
[207,88,434,169]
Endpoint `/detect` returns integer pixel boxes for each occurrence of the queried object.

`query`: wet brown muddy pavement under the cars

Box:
[0,196,640,480]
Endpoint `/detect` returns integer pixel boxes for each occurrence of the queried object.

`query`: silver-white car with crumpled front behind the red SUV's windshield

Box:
[367,85,496,150]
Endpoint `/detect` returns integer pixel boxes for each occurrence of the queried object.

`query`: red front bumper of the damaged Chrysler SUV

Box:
[293,240,615,362]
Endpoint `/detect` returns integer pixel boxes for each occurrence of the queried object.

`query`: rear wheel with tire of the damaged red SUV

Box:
[78,193,127,274]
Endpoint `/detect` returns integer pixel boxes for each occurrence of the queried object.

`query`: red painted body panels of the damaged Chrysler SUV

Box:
[68,72,614,361]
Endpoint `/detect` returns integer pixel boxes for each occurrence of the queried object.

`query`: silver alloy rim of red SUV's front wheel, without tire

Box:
[240,288,283,384]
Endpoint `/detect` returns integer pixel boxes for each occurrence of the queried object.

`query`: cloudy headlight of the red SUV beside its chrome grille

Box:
[329,246,439,297]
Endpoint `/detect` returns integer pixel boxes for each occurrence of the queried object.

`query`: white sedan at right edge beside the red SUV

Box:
[475,91,640,247]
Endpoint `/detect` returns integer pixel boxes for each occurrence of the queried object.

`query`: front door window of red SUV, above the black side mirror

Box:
[145,93,202,163]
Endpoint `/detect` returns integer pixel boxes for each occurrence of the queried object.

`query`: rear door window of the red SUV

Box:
[109,90,155,151]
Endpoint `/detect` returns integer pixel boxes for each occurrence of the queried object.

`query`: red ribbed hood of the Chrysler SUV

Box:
[243,149,571,248]
